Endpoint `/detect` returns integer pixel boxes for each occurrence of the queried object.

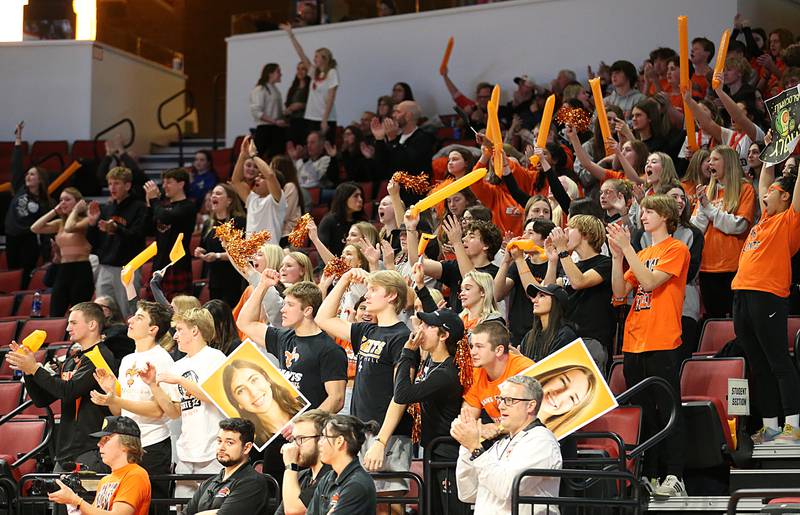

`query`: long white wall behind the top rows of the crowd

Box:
[226,0,736,144]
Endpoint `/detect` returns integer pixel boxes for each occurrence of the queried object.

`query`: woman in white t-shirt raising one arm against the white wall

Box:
[280,23,339,144]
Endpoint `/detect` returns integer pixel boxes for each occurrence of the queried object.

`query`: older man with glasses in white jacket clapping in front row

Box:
[450,376,561,515]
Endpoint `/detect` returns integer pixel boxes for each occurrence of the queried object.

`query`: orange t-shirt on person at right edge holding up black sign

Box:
[731,206,800,297]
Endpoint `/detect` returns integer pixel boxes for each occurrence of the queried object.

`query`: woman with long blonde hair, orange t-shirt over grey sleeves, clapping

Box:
[692,145,755,318]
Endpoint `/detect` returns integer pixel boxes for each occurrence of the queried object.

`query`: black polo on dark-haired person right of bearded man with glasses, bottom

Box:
[306,458,378,515]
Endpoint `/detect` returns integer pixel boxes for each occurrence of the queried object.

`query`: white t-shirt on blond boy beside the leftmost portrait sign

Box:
[172,346,225,463]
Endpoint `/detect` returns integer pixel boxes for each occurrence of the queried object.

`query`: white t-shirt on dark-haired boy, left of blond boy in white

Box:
[119,345,178,447]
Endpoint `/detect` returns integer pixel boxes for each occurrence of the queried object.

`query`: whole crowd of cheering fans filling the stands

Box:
[6,10,800,513]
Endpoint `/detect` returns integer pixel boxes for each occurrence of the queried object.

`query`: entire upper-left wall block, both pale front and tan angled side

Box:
[0,41,186,153]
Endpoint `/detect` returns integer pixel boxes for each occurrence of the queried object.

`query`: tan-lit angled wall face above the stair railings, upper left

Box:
[91,46,186,154]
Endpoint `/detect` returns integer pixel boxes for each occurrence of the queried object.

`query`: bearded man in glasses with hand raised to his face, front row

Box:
[275,409,331,515]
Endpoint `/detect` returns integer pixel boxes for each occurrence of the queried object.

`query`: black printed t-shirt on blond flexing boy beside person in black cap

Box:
[350,322,411,436]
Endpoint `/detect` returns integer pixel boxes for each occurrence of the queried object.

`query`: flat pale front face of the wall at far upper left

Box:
[0,41,92,142]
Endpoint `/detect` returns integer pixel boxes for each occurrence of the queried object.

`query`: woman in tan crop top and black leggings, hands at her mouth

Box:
[28,187,94,317]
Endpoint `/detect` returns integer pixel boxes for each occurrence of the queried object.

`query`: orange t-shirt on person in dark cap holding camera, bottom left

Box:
[92,463,150,515]
